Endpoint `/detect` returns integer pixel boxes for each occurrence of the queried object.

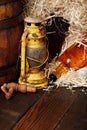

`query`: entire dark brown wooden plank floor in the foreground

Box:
[0,87,87,130]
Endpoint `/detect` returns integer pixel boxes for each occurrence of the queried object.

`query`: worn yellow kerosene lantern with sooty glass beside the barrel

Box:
[19,16,48,88]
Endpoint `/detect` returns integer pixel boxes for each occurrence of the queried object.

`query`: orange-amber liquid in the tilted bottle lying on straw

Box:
[50,41,87,78]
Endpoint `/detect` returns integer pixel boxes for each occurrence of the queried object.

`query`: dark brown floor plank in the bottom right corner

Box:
[55,89,87,130]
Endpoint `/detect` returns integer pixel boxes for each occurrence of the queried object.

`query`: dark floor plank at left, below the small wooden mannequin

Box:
[0,91,43,130]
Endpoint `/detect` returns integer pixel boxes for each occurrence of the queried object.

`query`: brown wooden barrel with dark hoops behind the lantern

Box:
[0,0,24,85]
